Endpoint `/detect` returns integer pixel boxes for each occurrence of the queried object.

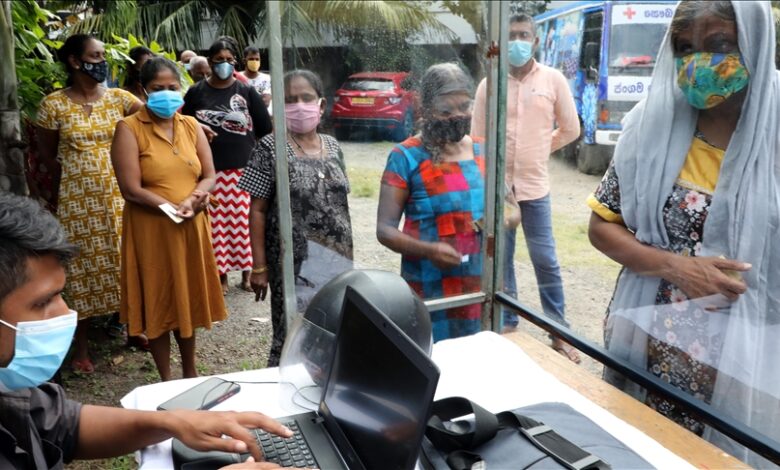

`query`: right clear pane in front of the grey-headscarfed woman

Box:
[505,1,780,468]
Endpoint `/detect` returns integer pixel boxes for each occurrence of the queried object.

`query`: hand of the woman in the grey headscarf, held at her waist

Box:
[664,256,751,302]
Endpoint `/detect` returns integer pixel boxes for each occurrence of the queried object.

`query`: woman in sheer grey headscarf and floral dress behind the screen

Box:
[589,1,780,467]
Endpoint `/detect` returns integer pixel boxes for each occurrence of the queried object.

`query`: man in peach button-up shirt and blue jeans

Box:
[471,14,580,363]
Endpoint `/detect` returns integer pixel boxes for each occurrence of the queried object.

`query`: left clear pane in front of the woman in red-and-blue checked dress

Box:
[267,1,496,339]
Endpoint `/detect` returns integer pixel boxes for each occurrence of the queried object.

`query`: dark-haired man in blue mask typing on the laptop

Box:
[0,193,292,469]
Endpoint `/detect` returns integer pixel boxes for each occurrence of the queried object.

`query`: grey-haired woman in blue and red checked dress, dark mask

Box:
[377,64,485,341]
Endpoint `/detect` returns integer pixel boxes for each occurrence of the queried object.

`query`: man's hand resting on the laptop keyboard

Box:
[164,410,293,460]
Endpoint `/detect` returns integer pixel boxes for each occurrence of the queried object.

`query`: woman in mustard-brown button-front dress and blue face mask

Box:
[111,57,227,380]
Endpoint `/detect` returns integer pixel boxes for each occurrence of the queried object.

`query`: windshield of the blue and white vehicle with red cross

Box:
[609,23,667,75]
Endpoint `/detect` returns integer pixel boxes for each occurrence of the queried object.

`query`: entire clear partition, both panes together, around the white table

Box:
[264,1,780,466]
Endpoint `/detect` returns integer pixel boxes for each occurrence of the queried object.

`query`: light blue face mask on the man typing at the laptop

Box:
[0,310,78,391]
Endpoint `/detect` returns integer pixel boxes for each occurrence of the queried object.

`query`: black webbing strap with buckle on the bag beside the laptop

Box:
[425,397,611,470]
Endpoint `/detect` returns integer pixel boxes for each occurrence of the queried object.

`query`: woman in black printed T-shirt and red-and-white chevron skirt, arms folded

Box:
[182,36,271,293]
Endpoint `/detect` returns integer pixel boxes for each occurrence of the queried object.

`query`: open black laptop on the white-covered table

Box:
[173,287,439,470]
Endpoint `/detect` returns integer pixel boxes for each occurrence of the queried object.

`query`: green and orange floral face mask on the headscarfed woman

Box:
[676,52,750,109]
